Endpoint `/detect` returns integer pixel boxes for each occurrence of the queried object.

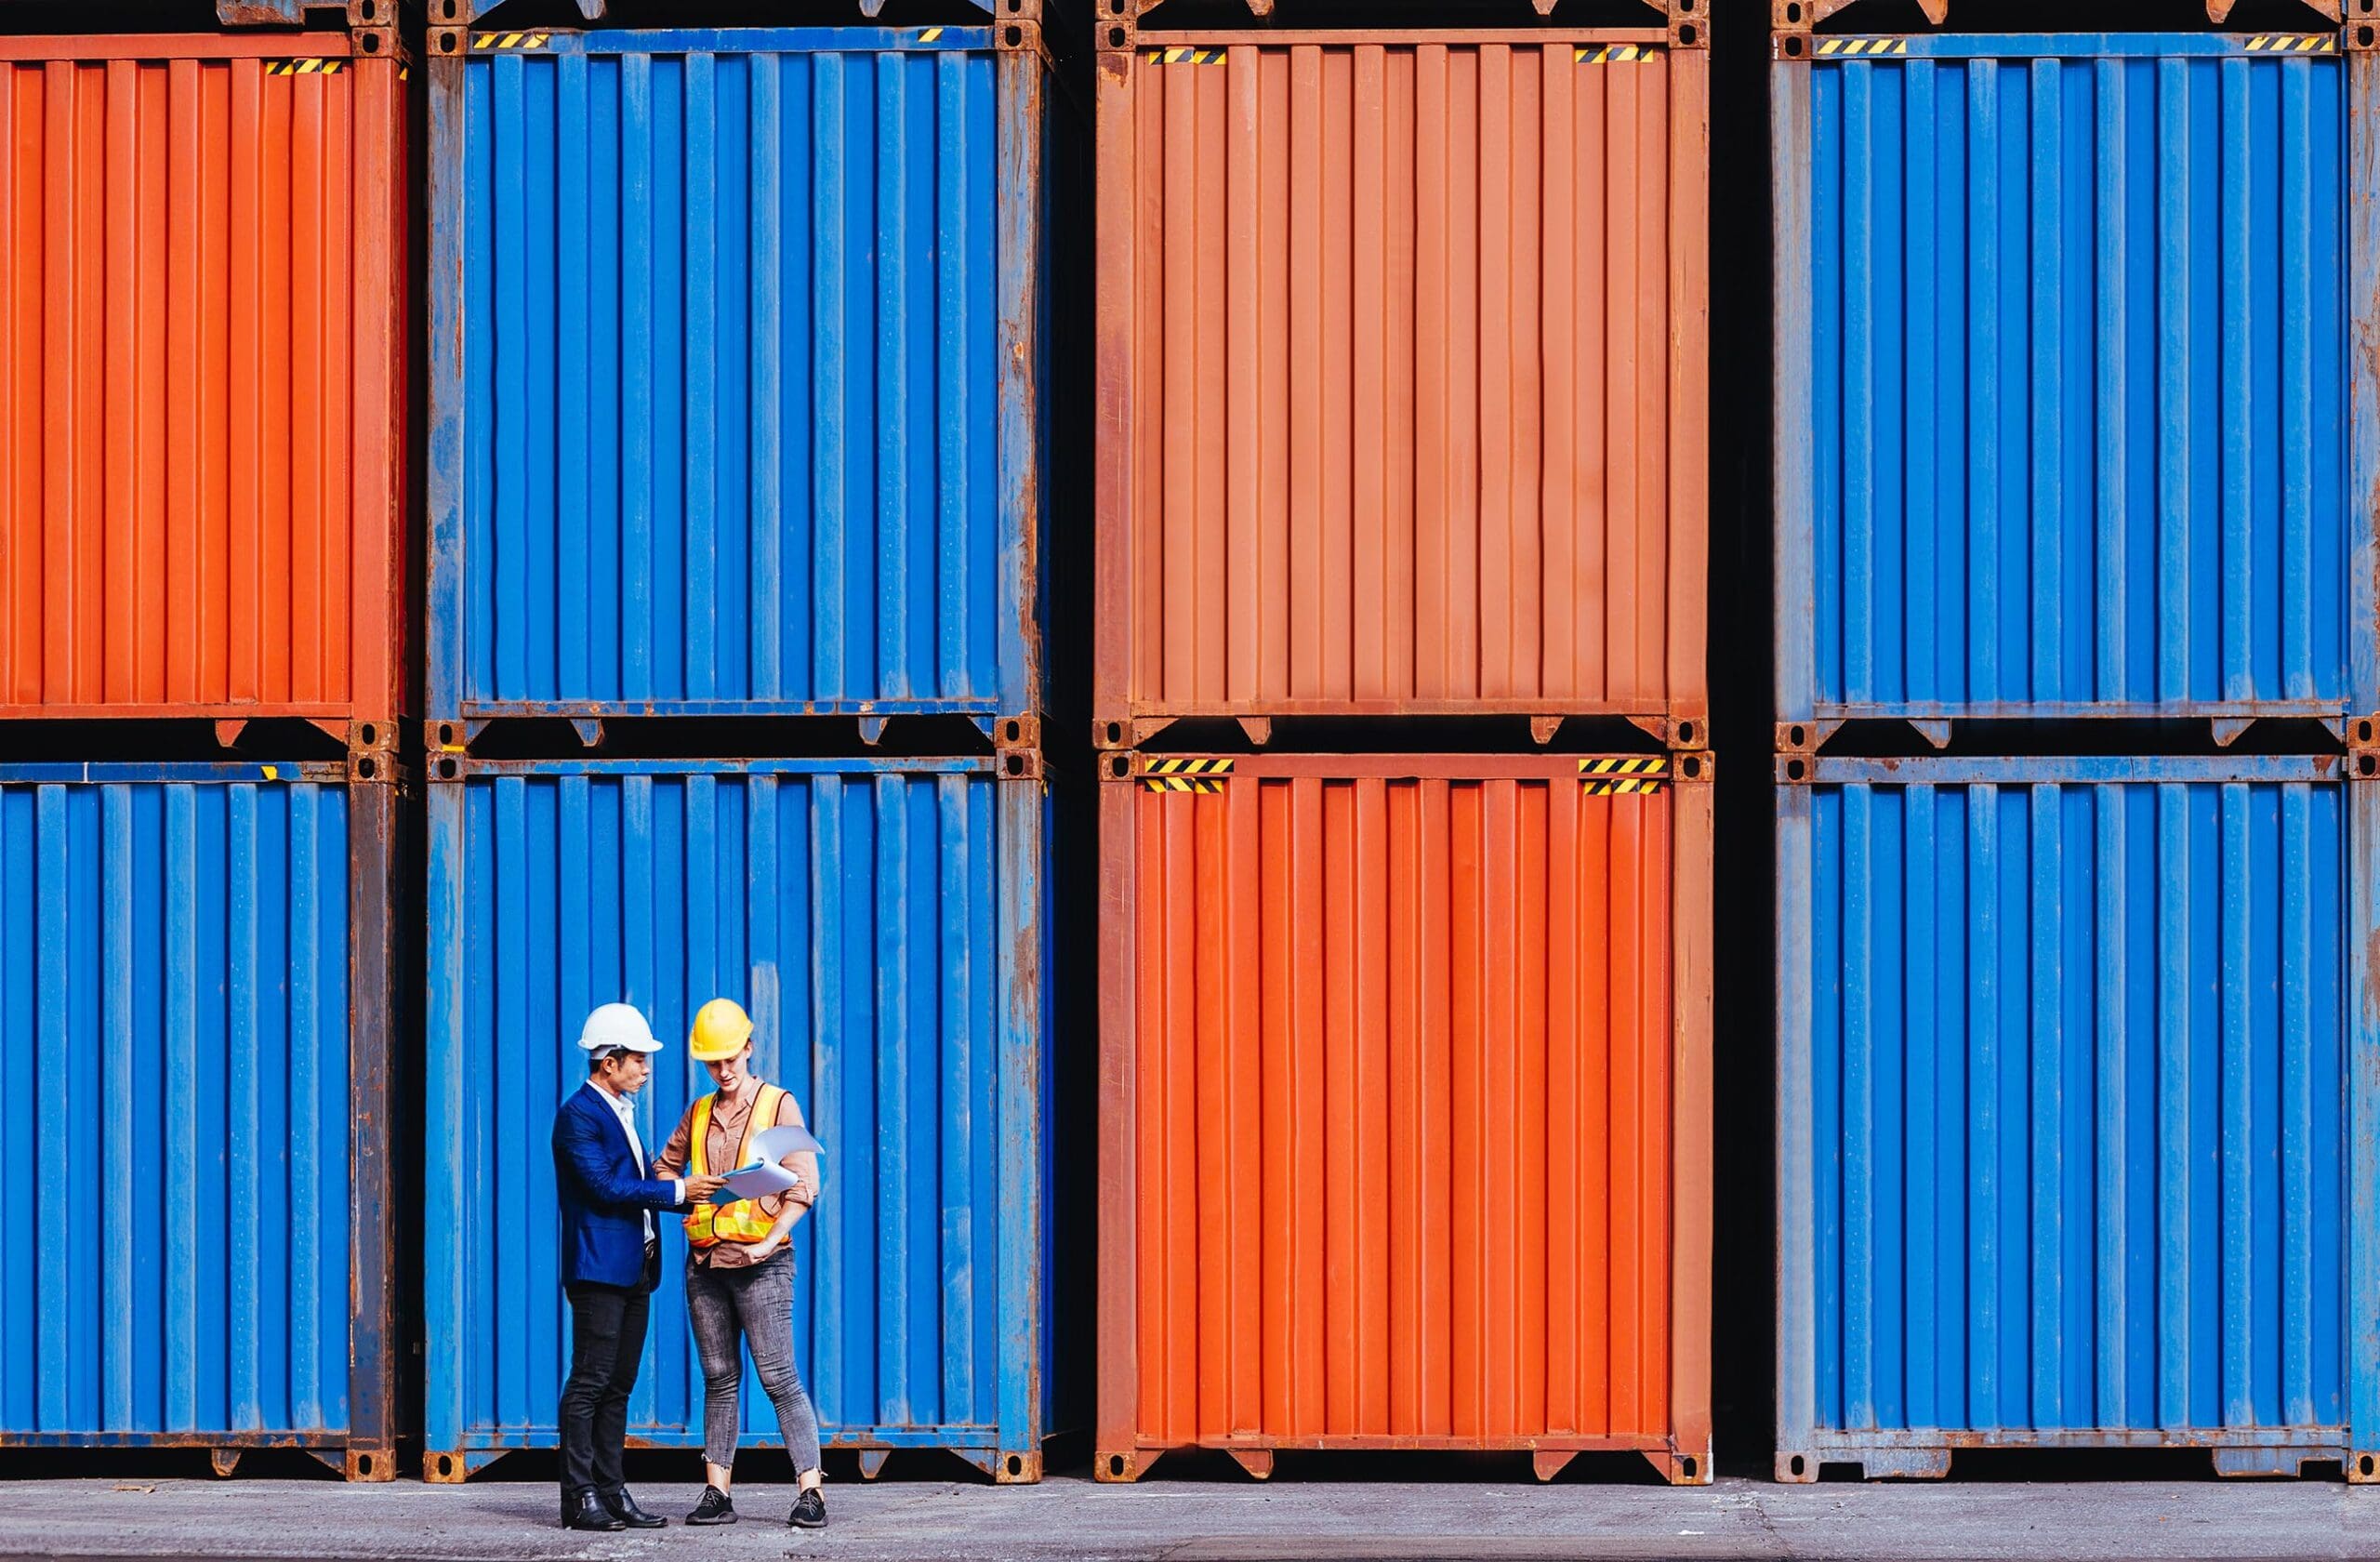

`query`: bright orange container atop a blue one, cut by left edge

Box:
[0,33,407,724]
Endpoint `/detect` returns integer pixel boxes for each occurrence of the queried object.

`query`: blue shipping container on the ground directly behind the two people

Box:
[426,760,1047,1478]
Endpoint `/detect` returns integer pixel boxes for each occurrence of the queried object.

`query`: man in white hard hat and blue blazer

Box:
[554,1002,723,1529]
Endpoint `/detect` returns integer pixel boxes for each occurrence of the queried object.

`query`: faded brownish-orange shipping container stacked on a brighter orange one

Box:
[1092,19,1709,748]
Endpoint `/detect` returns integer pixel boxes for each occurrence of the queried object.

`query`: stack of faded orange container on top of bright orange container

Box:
[1092,0,1712,1481]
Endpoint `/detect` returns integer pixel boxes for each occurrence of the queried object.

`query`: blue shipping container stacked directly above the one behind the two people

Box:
[430,26,1045,719]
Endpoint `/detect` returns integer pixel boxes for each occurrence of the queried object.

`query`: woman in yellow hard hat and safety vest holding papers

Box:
[652,998,826,1529]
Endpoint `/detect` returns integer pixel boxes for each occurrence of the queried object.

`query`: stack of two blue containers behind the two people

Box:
[426,0,1080,1481]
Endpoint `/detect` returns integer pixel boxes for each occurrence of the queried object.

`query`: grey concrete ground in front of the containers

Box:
[14,1478,2380,1562]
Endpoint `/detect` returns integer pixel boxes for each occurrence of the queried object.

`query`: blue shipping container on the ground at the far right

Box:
[1776,755,2380,1481]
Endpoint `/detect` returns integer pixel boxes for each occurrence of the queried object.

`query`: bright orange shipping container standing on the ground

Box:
[1095,755,1712,1481]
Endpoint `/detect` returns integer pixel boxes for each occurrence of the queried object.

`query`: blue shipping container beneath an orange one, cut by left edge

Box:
[0,762,398,1481]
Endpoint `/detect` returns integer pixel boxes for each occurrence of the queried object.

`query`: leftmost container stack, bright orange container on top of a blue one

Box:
[0,3,409,1478]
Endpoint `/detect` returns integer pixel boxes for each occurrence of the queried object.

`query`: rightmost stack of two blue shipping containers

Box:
[1771,7,2380,1481]
